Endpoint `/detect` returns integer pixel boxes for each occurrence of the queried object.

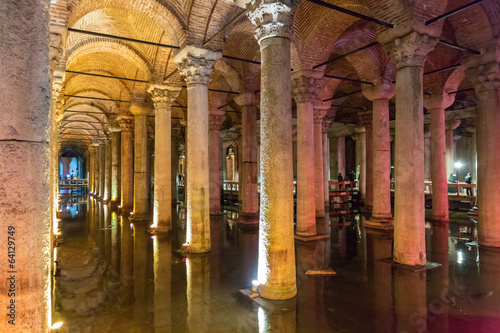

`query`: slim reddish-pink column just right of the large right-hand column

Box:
[424,90,460,224]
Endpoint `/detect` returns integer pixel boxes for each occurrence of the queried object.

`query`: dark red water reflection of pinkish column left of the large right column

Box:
[367,233,395,332]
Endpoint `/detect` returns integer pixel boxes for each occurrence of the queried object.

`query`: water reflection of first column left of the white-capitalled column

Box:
[153,235,172,333]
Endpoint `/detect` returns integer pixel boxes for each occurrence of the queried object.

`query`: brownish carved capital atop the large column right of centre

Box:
[385,31,438,69]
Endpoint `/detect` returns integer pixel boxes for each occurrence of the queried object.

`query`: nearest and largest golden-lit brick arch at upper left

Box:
[68,0,186,45]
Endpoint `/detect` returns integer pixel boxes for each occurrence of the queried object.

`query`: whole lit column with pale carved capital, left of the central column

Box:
[174,45,221,253]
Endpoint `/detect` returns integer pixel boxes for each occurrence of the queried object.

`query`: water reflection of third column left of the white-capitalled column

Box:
[120,216,134,305]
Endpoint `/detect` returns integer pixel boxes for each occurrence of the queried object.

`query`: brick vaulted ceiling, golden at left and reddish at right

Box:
[51,0,500,148]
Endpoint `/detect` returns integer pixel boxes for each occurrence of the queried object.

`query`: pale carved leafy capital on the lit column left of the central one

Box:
[174,45,222,85]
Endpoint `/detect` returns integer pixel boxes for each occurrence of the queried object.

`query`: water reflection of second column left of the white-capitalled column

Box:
[134,223,153,323]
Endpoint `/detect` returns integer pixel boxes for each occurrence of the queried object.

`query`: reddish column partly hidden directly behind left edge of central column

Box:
[234,92,259,219]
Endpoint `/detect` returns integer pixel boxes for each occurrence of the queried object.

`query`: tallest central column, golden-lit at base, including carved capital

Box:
[248,1,296,299]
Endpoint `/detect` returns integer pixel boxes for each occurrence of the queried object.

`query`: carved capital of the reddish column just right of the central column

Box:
[292,69,323,103]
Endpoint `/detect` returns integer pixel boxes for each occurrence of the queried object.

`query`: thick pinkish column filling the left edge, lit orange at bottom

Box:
[0,0,52,332]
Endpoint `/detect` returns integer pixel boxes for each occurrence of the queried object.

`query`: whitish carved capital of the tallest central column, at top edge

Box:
[247,0,299,43]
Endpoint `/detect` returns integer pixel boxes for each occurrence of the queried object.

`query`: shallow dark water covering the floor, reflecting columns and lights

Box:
[53,199,500,333]
